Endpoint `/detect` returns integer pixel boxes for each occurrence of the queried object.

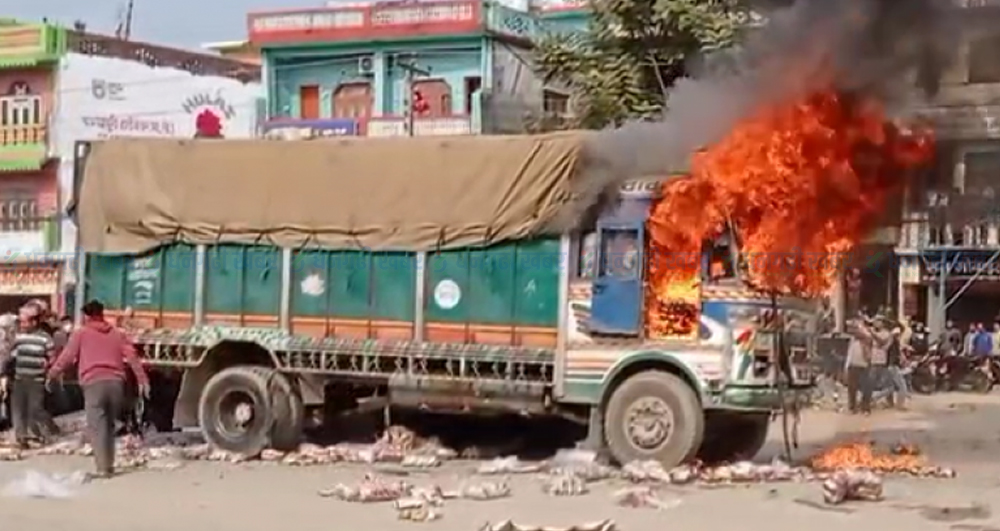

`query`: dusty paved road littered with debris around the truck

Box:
[0,396,1000,531]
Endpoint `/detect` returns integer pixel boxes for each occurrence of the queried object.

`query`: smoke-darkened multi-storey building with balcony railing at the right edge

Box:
[896,0,1000,330]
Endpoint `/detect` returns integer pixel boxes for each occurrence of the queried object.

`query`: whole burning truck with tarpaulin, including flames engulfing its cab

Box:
[68,77,931,466]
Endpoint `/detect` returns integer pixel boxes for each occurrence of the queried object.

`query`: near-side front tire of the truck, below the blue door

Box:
[604,371,705,468]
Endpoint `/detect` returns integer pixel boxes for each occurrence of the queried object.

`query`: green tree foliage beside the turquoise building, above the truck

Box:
[535,0,750,128]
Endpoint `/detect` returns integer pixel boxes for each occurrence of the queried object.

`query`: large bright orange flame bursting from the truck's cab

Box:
[649,91,933,336]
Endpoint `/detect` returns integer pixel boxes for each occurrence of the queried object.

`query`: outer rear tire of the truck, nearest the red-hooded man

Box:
[198,366,274,455]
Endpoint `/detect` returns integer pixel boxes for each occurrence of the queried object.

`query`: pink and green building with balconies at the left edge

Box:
[0,20,66,311]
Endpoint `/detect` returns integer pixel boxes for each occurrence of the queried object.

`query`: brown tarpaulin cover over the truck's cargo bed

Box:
[76,132,594,253]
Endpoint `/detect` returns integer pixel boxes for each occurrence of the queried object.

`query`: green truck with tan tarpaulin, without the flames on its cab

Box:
[70,138,815,466]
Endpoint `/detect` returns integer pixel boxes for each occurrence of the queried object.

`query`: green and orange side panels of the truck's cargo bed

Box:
[85,239,560,348]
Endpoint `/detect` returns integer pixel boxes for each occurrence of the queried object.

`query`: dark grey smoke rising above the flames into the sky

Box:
[593,0,959,179]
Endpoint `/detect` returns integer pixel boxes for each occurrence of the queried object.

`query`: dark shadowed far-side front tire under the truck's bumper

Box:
[698,414,771,464]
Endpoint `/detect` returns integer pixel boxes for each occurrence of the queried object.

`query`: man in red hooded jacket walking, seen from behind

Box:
[48,301,149,477]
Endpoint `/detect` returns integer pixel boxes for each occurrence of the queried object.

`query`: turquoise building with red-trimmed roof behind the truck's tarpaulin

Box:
[248,0,585,136]
